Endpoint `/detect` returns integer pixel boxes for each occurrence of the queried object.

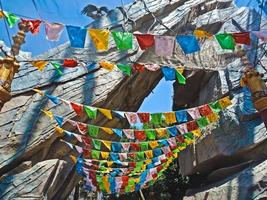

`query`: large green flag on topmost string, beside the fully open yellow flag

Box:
[112,31,133,51]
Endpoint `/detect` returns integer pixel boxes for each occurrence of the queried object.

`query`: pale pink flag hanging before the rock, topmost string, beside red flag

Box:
[155,35,175,56]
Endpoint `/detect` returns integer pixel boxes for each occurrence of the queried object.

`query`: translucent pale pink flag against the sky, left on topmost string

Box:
[45,22,64,42]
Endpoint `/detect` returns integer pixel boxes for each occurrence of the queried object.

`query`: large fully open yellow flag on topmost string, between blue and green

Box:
[88,29,109,51]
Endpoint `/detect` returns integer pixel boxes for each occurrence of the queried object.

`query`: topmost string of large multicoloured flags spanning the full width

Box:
[0,11,267,56]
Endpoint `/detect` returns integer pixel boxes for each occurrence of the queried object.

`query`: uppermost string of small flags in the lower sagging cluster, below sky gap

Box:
[37,89,232,126]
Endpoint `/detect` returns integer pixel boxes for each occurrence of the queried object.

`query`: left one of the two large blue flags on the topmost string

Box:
[66,26,87,48]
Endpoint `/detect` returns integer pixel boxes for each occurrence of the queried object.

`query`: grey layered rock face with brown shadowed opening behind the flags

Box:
[0,0,267,200]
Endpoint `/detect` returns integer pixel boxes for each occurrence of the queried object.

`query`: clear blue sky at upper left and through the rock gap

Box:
[0,0,173,112]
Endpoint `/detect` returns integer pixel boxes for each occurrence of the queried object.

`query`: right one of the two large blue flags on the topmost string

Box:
[176,35,200,54]
